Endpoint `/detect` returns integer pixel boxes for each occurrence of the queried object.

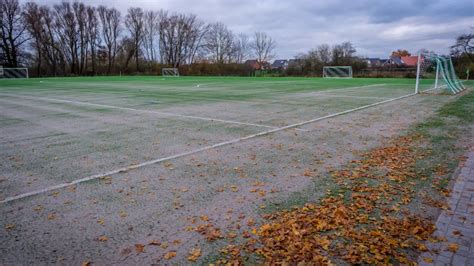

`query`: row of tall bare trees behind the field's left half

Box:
[0,0,276,76]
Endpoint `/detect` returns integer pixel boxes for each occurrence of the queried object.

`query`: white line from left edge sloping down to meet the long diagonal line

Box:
[0,94,307,131]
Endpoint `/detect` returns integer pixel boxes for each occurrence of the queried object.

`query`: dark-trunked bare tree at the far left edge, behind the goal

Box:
[0,0,28,67]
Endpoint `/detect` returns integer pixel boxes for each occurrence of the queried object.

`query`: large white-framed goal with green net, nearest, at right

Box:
[416,52,465,94]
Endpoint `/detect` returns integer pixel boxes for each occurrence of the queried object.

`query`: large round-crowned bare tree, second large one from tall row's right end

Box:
[204,22,235,64]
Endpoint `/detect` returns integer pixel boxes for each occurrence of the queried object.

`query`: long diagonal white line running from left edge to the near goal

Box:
[0,93,416,204]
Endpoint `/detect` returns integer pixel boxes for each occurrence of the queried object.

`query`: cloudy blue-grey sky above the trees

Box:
[31,0,474,59]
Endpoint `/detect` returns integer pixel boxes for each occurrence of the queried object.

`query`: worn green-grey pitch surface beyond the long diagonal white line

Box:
[0,77,420,199]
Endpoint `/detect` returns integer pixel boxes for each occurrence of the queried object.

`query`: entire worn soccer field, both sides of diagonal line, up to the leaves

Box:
[0,77,466,263]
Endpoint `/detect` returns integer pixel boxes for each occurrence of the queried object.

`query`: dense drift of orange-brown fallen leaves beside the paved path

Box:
[209,136,456,264]
